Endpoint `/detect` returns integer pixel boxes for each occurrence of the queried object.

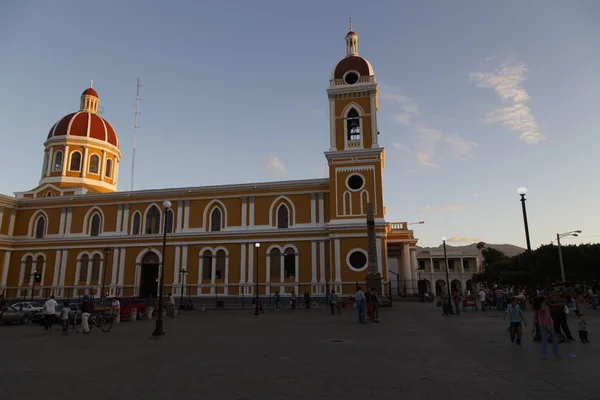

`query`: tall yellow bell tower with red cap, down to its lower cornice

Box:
[325,26,384,225]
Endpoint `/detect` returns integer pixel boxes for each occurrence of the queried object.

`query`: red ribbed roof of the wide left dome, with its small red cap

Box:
[48,111,119,147]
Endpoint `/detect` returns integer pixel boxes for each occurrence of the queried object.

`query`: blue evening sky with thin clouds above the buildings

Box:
[0,0,600,248]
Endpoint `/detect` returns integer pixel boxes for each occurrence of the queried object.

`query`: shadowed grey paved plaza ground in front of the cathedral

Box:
[0,303,600,400]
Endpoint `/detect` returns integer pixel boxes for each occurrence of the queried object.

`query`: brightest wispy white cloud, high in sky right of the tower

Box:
[469,63,545,144]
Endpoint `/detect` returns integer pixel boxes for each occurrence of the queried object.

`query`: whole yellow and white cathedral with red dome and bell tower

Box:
[0,31,418,299]
